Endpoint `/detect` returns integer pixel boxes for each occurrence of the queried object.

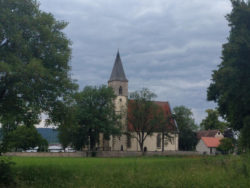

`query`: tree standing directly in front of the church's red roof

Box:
[128,88,166,152]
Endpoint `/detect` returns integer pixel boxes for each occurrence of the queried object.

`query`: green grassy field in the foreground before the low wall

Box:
[6,156,250,188]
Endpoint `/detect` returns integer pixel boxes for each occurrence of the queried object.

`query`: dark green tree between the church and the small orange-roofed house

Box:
[173,106,198,151]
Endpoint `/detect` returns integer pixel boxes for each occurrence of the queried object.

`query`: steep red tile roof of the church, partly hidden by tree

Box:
[128,100,177,132]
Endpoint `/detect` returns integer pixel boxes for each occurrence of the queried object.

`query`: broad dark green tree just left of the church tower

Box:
[58,86,120,150]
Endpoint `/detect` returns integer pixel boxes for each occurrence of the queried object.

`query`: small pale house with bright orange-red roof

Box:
[196,137,222,155]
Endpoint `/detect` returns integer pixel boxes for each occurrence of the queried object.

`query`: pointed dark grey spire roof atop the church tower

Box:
[109,50,128,82]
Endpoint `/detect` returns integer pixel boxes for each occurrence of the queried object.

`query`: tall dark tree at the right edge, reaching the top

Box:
[207,0,250,149]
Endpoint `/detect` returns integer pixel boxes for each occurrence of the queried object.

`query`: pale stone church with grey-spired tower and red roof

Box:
[99,51,178,151]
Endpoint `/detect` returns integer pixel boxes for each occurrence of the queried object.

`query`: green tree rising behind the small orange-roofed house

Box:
[200,109,229,131]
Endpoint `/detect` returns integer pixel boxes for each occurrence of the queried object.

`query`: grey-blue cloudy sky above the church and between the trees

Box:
[40,0,231,123]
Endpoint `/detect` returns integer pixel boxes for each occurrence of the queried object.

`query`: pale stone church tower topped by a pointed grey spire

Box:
[108,51,128,150]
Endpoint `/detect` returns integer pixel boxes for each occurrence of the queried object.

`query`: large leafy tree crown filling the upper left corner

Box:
[0,0,76,134]
